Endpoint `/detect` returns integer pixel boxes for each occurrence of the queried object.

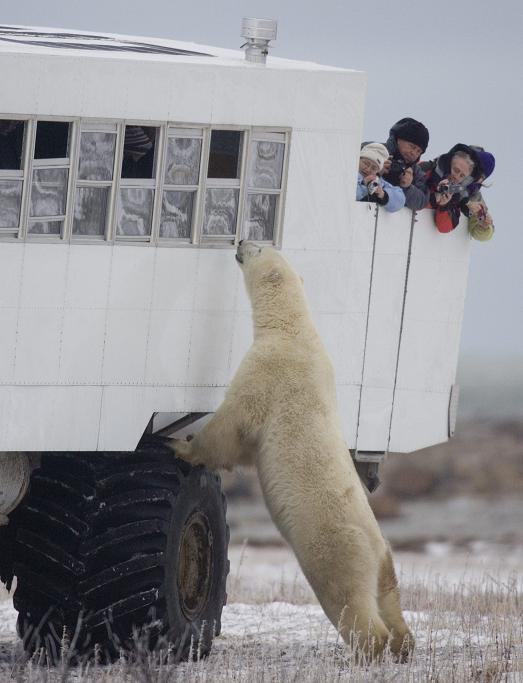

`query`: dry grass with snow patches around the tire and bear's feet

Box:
[0,559,523,683]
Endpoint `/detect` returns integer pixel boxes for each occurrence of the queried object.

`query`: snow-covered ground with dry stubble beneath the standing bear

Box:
[0,543,523,683]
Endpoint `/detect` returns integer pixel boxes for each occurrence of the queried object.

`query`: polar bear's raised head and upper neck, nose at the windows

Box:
[236,241,310,334]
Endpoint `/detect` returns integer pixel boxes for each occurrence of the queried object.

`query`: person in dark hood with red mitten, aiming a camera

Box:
[420,143,481,232]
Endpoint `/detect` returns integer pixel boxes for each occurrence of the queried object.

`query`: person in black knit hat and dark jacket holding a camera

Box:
[374,117,429,211]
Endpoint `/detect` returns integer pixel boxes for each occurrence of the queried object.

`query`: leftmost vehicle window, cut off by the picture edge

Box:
[0,119,25,236]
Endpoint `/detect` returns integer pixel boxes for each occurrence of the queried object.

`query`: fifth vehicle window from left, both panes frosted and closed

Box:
[159,128,203,240]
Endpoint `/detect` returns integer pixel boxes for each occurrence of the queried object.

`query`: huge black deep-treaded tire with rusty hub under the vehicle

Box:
[9,442,229,661]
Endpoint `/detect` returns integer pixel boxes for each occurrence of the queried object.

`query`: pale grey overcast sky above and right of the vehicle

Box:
[0,0,523,357]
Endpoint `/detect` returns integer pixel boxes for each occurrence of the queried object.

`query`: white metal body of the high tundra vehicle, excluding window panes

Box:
[0,28,470,462]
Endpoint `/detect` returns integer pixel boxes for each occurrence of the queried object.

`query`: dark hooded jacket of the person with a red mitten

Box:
[420,143,481,232]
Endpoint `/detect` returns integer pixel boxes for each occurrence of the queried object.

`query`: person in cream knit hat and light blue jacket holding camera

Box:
[356,142,405,212]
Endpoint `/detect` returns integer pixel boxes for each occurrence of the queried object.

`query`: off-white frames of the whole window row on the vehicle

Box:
[0,114,292,248]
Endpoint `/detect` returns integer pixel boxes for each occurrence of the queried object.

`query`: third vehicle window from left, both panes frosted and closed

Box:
[73,124,117,238]
